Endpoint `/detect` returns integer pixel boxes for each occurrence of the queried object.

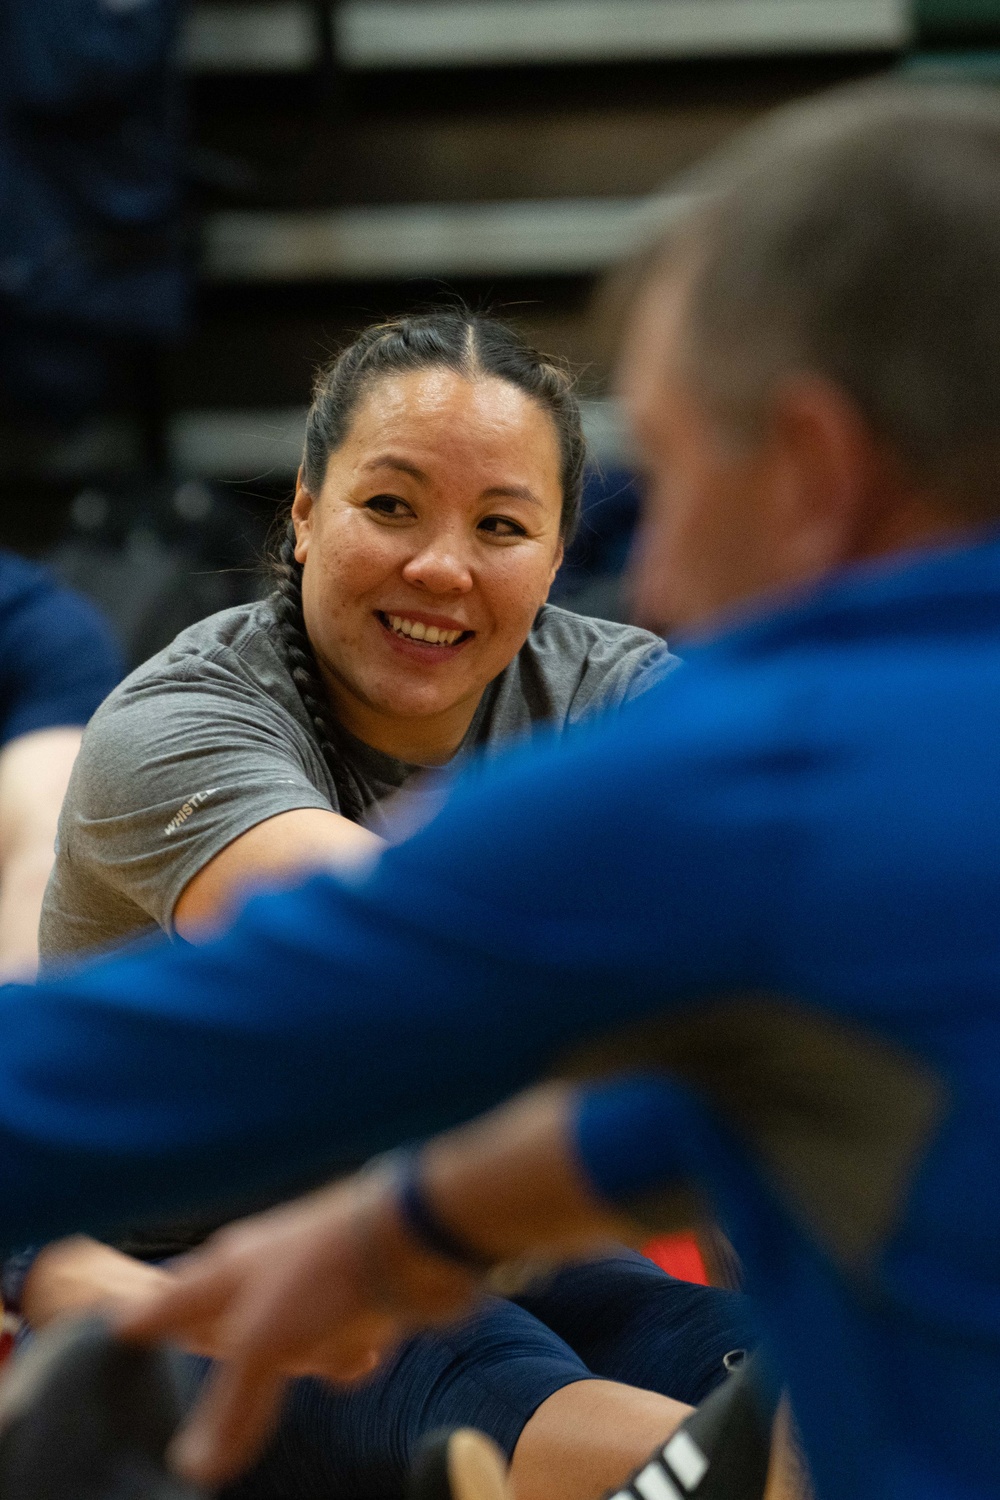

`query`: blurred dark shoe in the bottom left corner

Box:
[0,1317,206,1500]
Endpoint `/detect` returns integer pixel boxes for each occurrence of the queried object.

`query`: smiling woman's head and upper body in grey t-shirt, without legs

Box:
[40,309,672,965]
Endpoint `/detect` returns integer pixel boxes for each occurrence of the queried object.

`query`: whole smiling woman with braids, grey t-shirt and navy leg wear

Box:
[16,311,747,1500]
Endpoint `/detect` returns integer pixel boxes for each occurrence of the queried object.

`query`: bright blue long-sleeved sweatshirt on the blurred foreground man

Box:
[0,536,1000,1500]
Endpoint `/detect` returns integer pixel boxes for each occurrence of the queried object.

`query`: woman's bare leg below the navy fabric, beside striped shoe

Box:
[510,1380,693,1500]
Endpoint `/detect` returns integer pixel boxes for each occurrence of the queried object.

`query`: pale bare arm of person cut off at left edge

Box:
[0,728,82,981]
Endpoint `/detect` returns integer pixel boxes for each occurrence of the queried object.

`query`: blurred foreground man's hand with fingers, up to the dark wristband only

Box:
[118,1172,477,1485]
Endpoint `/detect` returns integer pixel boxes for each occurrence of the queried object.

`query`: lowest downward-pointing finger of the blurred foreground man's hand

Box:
[169,1361,285,1487]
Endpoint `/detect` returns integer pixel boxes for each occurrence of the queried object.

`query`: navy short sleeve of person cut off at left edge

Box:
[0,557,124,746]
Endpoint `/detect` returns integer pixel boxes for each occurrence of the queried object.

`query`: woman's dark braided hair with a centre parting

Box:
[273,308,586,822]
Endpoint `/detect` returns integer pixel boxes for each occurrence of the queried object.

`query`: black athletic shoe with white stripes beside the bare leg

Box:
[610,1359,774,1500]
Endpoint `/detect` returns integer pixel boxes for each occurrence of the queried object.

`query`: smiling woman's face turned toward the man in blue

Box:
[292,369,562,764]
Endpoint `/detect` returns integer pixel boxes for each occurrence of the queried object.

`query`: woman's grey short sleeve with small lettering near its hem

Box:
[57,660,336,932]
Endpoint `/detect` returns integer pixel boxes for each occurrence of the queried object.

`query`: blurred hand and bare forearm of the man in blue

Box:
[120,1085,624,1485]
